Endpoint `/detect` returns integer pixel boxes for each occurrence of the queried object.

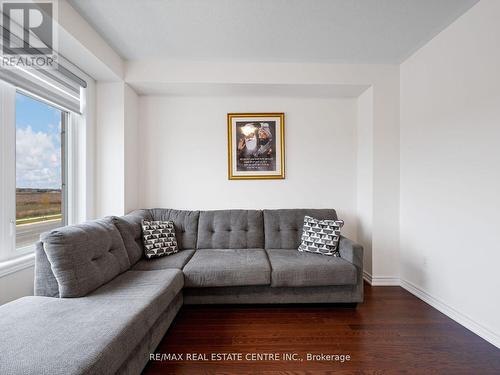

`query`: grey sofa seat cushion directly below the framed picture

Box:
[183,249,271,287]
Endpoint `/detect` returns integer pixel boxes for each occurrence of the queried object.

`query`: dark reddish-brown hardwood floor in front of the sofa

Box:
[144,285,500,375]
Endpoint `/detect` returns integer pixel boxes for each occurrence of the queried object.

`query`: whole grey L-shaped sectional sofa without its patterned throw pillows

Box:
[0,209,363,375]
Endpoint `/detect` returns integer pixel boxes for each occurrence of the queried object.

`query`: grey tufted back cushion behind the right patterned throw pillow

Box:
[264,209,337,249]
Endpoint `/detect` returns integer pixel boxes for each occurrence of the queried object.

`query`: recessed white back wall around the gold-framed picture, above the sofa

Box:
[140,96,357,238]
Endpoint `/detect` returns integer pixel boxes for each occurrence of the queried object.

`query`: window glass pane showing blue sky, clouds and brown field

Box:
[15,91,68,252]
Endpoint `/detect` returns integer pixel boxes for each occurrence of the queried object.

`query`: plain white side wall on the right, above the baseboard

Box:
[400,0,500,347]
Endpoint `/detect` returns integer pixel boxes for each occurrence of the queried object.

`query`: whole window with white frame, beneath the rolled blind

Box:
[0,75,87,264]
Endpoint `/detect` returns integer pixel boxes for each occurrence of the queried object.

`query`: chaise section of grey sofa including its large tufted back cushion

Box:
[24,217,184,374]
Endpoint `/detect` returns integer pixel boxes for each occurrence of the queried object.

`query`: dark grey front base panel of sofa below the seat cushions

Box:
[183,285,363,304]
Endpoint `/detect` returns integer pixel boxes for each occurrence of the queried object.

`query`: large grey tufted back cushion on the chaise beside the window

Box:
[40,218,130,297]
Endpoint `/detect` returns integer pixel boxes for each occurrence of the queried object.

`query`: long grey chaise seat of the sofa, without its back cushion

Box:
[0,270,183,375]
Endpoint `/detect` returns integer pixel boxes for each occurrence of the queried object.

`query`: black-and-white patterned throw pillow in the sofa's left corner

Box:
[141,220,178,259]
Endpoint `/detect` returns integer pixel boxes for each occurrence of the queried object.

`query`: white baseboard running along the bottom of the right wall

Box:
[401,280,500,348]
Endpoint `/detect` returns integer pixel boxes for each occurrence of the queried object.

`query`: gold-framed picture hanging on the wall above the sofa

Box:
[227,113,285,180]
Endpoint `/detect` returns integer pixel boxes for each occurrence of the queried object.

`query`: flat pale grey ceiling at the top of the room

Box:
[68,0,478,63]
